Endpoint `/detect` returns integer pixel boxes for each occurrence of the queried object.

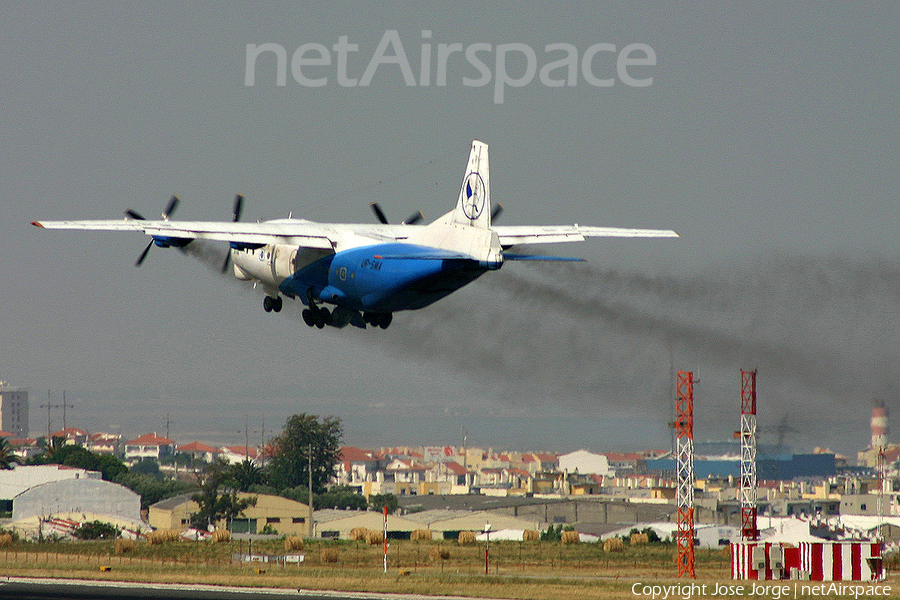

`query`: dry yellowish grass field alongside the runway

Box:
[0,540,900,600]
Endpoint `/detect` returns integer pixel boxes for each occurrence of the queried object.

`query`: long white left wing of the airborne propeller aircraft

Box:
[32,219,409,250]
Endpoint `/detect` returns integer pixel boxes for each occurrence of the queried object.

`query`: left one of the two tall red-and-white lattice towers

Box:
[675,371,694,579]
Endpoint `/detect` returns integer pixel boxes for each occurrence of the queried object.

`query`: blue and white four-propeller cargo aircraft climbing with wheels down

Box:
[32,140,678,329]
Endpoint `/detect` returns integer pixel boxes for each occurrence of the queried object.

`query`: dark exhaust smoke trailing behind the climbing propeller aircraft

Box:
[187,243,900,449]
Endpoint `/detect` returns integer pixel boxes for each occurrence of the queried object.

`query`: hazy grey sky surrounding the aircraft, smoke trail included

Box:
[0,1,900,452]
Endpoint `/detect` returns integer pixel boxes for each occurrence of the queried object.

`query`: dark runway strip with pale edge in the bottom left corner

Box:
[0,577,486,600]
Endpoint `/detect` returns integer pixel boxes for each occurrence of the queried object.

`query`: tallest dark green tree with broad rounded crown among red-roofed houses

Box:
[269,413,344,494]
